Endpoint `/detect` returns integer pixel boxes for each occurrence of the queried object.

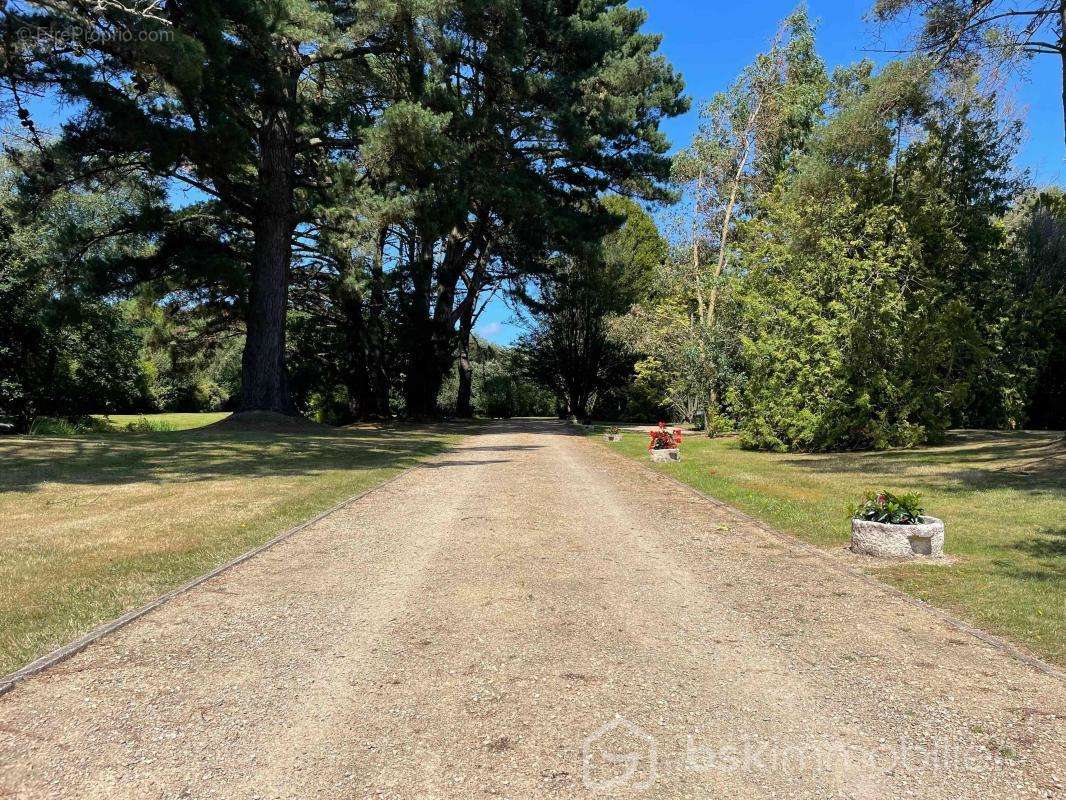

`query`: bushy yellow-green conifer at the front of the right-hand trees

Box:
[739,202,936,450]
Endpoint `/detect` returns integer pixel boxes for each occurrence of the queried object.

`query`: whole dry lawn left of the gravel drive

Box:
[0,415,452,675]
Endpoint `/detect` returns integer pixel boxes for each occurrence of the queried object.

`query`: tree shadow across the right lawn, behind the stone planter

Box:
[782,431,1066,493]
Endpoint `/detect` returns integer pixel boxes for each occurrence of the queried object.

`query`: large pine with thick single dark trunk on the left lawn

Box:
[4,0,390,413]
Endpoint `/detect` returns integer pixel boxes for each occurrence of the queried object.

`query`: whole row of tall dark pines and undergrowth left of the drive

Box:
[0,0,688,433]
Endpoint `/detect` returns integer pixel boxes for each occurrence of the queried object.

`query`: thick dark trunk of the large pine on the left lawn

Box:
[241,108,295,414]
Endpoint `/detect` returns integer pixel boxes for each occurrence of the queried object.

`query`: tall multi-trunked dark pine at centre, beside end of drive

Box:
[370,0,687,415]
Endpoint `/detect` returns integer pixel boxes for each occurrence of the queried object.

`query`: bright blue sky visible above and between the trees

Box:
[478,0,1066,343]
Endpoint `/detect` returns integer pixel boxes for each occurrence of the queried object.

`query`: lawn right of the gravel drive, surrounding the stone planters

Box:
[597,431,1066,665]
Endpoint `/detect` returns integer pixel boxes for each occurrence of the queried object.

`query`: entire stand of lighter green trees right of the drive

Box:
[533,11,1066,450]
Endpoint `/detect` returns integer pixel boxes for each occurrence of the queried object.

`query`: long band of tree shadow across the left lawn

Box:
[0,426,457,492]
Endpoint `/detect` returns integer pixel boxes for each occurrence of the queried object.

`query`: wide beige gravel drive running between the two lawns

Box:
[0,422,1066,800]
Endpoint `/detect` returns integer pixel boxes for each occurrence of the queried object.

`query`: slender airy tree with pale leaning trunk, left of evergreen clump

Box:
[612,7,828,434]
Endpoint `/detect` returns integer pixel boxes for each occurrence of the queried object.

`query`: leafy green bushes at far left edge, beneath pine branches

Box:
[0,161,157,430]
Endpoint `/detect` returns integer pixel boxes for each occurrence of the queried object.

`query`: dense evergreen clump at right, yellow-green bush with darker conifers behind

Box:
[733,54,1018,450]
